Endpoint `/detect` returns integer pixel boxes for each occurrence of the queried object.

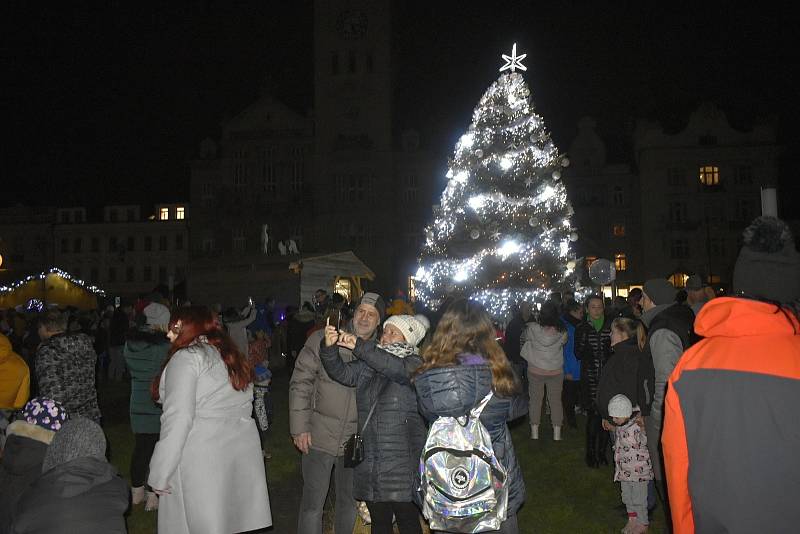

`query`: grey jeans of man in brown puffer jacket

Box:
[297,449,356,534]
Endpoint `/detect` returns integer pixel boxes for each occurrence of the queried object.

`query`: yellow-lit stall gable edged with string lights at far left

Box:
[0,267,105,309]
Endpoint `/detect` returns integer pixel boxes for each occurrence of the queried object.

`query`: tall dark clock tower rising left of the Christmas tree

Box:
[314,0,394,284]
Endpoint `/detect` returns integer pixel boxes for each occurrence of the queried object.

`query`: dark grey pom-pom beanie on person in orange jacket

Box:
[733,217,800,303]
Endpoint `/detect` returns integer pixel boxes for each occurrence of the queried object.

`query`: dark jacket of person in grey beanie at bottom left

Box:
[11,457,130,534]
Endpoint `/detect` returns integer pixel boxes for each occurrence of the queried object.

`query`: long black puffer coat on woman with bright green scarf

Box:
[575,317,612,410]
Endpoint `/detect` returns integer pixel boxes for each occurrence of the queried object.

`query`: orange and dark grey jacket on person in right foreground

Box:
[661,297,800,534]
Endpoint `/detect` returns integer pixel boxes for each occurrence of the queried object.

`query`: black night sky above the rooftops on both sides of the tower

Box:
[6,0,800,216]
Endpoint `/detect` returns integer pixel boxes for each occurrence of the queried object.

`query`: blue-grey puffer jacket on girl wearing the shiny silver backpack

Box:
[414,354,528,514]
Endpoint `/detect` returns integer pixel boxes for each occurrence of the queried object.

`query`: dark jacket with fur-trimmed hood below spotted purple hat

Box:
[0,421,54,534]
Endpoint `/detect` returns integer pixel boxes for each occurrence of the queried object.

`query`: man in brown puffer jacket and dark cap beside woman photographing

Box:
[289,293,386,534]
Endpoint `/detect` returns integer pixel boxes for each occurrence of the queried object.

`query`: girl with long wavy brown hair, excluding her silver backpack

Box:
[414,299,528,534]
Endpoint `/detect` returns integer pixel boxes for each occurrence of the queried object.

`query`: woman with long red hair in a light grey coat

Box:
[148,306,272,534]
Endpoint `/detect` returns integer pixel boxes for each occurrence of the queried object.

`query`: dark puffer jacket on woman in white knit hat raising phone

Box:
[319,339,426,502]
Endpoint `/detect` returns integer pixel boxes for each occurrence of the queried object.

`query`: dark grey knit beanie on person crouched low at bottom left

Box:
[42,415,106,473]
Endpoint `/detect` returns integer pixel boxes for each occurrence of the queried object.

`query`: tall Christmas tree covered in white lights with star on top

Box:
[415,44,578,317]
